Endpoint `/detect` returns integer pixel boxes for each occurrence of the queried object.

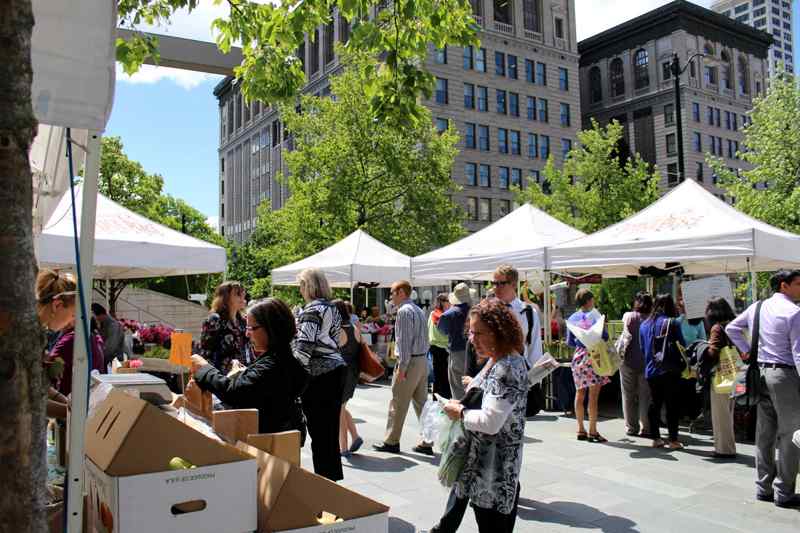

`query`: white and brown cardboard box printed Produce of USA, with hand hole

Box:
[86,390,257,533]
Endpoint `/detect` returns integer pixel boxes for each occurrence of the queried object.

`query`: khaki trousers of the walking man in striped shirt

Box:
[383,357,428,444]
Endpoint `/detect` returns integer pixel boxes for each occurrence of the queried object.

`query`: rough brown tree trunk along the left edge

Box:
[0,0,47,533]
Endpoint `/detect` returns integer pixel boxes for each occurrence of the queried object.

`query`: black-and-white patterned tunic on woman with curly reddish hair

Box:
[455,354,528,514]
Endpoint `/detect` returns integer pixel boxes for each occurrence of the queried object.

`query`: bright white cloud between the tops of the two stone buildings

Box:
[575,0,712,41]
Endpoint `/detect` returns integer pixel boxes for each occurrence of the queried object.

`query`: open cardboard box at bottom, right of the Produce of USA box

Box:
[237,442,389,533]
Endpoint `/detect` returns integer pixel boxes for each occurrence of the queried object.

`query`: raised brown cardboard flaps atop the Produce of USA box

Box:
[85,390,250,476]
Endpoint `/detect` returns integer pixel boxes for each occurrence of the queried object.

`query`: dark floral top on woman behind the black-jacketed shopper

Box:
[200,313,255,374]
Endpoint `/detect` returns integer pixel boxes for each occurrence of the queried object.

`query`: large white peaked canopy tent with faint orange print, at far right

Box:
[548,180,800,277]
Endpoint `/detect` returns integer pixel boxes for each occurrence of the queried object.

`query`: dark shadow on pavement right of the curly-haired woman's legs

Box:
[517,498,638,533]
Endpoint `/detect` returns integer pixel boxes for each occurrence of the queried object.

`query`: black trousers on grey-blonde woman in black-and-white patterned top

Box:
[302,366,347,481]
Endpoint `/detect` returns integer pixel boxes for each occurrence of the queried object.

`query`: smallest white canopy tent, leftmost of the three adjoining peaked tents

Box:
[272,230,424,289]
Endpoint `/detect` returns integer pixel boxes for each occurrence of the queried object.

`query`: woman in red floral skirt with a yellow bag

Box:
[567,289,611,442]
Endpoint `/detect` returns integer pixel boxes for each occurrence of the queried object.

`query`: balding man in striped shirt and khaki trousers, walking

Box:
[373,281,433,455]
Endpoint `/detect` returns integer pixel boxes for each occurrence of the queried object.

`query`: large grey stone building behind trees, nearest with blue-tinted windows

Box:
[214,0,581,242]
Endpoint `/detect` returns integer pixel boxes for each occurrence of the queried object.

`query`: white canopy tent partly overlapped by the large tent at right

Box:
[411,204,586,281]
